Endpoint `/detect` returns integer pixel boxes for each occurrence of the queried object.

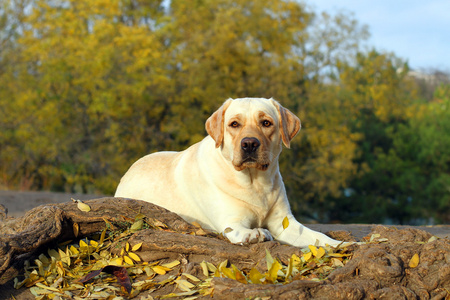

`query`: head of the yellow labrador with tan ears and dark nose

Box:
[206,98,300,171]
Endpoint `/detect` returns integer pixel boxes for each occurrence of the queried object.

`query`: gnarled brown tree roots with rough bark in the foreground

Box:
[0,198,450,299]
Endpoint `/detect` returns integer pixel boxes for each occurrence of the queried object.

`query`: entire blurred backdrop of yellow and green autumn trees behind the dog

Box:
[0,0,450,224]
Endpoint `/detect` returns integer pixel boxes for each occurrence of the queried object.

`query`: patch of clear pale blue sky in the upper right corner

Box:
[305,0,450,72]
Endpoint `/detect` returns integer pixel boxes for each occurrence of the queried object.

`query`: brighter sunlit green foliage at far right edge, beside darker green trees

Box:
[380,86,450,223]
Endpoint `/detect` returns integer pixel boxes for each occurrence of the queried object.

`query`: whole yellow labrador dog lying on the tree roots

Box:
[115,98,340,247]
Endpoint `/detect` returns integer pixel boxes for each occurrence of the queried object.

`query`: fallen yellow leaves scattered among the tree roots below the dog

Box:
[14,214,418,299]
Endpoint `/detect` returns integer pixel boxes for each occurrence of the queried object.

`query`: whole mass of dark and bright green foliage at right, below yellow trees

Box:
[331,78,450,224]
